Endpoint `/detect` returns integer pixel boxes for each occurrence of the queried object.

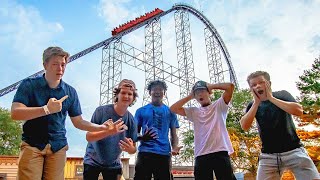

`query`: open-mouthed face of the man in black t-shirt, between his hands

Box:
[249,75,267,100]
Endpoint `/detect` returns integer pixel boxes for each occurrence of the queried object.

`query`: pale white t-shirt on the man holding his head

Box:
[184,97,234,157]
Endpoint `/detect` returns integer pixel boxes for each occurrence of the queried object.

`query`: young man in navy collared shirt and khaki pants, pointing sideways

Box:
[11,47,107,180]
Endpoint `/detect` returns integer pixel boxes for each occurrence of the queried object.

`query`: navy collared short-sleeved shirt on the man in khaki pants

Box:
[13,75,82,152]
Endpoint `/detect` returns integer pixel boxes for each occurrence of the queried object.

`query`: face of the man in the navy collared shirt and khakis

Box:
[43,56,67,81]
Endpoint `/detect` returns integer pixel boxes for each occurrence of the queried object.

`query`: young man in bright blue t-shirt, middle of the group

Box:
[134,80,181,180]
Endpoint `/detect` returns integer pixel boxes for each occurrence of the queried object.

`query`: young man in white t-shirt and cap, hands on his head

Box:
[170,81,236,180]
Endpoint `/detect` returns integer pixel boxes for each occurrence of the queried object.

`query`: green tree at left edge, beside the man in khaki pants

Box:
[0,107,22,155]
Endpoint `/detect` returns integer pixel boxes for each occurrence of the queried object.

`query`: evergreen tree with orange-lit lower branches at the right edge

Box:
[296,57,320,170]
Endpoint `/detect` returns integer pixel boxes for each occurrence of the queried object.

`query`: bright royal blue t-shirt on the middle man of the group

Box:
[134,104,179,156]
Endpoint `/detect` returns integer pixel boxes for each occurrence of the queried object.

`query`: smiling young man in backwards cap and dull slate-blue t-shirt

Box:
[83,79,138,180]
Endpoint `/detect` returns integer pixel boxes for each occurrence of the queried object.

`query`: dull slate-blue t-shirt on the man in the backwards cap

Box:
[84,104,137,169]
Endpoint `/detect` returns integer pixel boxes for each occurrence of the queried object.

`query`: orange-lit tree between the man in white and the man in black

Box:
[224,89,261,174]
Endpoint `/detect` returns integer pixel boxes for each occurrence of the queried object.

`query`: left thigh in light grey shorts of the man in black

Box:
[257,153,284,180]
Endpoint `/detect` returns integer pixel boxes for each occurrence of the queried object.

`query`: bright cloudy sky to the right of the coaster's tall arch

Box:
[205,1,320,95]
